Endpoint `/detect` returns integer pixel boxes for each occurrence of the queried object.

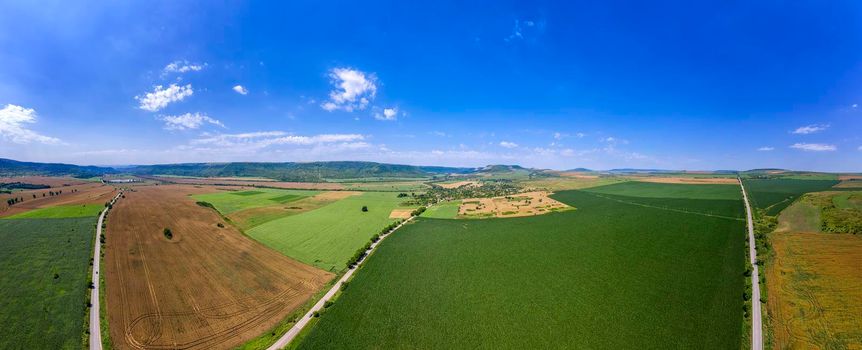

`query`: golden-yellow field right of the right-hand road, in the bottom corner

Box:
[766,232,862,349]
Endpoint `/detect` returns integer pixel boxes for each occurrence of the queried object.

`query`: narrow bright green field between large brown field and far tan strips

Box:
[192,188,320,215]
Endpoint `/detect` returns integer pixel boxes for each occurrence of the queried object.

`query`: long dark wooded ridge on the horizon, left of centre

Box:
[124,161,474,182]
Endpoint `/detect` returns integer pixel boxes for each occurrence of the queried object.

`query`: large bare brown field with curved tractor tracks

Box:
[104,185,333,349]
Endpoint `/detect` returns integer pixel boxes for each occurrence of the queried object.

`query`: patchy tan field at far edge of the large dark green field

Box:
[458,191,573,218]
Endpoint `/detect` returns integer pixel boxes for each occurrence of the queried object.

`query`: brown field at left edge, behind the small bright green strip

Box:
[0,182,116,217]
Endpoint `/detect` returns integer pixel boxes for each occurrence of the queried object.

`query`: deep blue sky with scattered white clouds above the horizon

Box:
[0,1,862,171]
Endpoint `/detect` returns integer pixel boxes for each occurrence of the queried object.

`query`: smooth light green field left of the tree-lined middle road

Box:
[246,192,416,271]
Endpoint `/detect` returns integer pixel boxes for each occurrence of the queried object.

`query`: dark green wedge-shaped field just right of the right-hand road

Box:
[743,179,838,215]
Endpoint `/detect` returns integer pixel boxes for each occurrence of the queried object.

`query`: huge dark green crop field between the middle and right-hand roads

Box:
[298,185,745,349]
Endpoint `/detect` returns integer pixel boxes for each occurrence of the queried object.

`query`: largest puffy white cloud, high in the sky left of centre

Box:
[320,68,377,112]
